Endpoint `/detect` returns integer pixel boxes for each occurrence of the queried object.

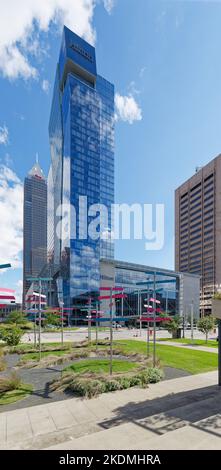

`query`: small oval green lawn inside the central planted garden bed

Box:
[64,359,139,374]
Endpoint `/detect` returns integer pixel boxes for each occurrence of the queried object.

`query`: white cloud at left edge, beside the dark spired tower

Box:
[0,165,23,268]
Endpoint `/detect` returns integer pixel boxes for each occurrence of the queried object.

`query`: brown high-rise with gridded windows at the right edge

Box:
[175,155,221,315]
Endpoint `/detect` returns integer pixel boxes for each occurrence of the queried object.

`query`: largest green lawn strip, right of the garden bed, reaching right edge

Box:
[116,340,218,374]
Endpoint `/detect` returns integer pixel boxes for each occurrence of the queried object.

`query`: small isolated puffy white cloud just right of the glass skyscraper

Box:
[115,93,142,124]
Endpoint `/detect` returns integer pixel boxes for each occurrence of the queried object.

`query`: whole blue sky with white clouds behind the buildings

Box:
[0,0,221,298]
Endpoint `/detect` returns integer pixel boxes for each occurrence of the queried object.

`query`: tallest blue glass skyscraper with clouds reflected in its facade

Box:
[48,27,114,307]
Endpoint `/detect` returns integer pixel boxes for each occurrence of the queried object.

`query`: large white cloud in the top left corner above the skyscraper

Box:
[0,0,97,79]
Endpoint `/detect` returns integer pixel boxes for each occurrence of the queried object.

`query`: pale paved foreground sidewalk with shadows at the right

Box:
[0,372,221,449]
